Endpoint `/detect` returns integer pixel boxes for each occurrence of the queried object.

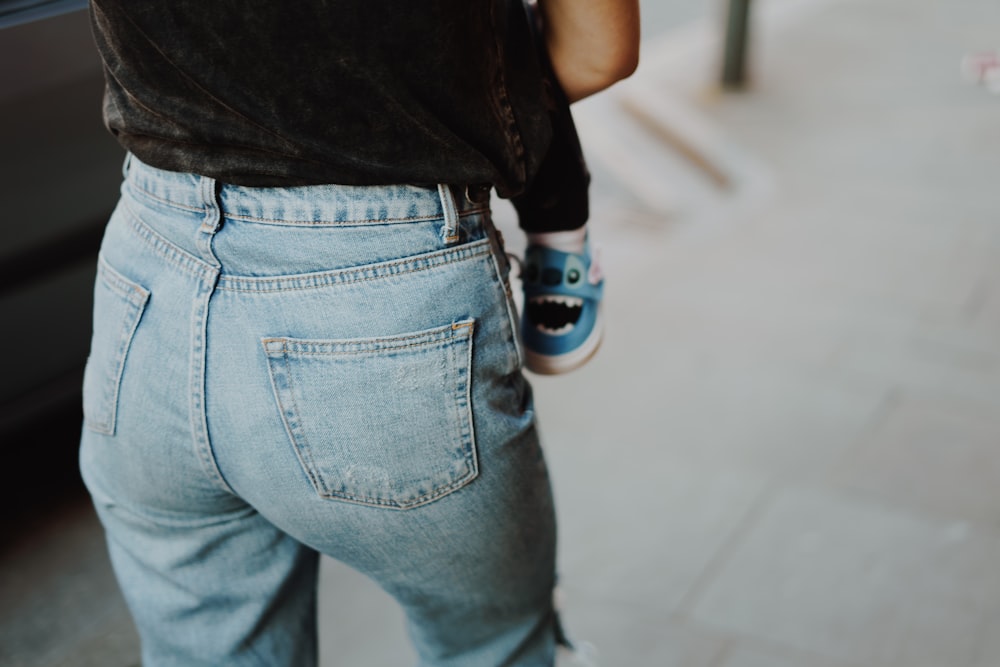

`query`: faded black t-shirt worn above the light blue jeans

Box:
[91,0,553,197]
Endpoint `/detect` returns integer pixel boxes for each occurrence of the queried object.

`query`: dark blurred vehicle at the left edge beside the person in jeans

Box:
[0,0,124,498]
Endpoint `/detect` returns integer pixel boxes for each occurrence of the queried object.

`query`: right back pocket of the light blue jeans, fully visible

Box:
[262,320,479,509]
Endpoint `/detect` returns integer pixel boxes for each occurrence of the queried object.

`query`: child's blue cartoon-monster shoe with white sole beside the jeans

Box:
[521,243,604,375]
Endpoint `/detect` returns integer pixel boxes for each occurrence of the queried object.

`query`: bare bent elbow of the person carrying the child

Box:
[538,0,639,102]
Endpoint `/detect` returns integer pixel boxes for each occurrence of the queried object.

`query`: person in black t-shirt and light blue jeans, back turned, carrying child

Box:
[80,0,638,667]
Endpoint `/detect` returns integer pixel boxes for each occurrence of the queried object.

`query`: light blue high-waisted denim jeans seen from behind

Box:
[80,158,558,667]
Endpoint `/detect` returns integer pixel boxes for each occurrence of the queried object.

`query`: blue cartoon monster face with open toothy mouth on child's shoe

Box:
[522,250,588,336]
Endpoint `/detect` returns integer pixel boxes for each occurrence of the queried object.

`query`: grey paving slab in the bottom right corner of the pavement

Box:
[691,488,1000,667]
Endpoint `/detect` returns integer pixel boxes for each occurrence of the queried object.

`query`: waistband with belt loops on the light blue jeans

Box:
[124,154,490,225]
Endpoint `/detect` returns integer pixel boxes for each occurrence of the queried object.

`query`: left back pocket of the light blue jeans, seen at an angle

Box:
[83,259,149,435]
